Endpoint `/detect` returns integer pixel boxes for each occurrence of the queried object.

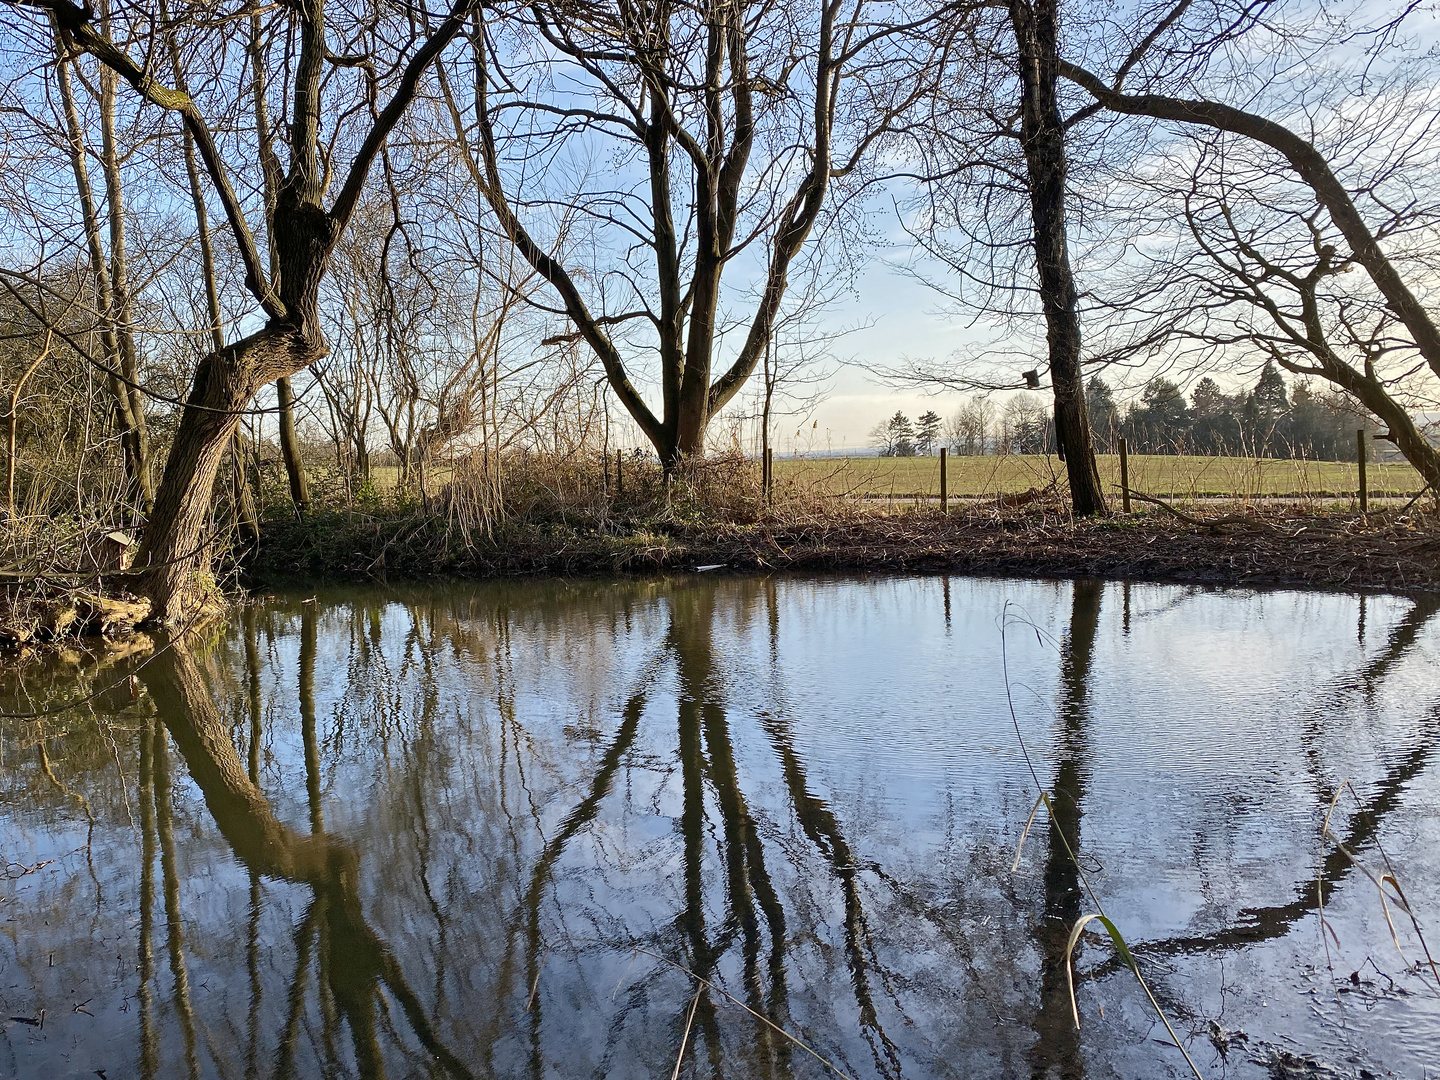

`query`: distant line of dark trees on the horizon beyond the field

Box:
[871,363,1393,461]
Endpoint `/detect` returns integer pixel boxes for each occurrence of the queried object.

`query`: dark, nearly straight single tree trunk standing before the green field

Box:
[1009,0,1106,517]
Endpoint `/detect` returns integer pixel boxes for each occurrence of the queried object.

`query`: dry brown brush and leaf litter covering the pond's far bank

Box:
[241,458,1440,590]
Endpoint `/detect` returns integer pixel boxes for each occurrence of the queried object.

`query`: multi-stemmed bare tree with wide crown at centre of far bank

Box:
[446,0,935,468]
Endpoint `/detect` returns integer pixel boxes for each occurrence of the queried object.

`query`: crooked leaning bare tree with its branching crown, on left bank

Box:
[4,0,480,622]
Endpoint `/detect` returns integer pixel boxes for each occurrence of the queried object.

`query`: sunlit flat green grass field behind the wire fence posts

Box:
[775,454,1423,500]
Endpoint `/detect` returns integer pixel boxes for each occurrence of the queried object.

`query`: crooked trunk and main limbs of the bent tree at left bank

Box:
[2,0,475,621]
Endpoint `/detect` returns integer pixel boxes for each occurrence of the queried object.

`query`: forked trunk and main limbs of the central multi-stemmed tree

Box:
[439,3,835,477]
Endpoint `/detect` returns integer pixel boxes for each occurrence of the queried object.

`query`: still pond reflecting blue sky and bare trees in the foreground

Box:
[0,575,1440,1080]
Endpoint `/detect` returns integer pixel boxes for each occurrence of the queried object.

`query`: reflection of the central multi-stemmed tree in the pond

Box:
[501,585,900,1077]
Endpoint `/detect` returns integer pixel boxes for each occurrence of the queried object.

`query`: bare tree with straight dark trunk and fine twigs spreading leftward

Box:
[887,0,1106,516]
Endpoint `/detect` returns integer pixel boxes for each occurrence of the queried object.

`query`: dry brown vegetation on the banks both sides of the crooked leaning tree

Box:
[0,455,1440,647]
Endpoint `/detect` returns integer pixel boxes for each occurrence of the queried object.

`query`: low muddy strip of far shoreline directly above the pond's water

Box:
[245,508,1440,592]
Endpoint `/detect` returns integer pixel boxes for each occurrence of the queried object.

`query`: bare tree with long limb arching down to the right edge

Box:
[1060,0,1440,484]
